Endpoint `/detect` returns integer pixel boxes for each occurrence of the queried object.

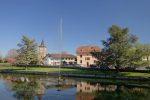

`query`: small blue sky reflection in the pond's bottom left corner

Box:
[0,80,16,100]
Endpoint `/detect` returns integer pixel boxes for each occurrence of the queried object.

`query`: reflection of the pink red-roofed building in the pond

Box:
[76,82,117,100]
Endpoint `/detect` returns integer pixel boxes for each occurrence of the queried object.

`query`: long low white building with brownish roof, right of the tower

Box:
[43,54,76,66]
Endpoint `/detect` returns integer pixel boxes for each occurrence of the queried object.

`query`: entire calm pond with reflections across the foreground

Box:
[0,74,150,100]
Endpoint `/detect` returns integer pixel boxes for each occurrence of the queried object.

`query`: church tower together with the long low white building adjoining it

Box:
[38,40,76,66]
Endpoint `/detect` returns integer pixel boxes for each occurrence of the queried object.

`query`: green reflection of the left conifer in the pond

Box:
[12,78,45,100]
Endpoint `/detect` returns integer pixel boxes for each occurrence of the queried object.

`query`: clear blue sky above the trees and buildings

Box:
[0,0,150,55]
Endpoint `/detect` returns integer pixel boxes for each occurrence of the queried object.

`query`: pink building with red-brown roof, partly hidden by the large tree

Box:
[76,46,101,67]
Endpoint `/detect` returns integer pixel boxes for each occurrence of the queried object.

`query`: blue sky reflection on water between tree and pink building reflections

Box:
[36,88,76,100]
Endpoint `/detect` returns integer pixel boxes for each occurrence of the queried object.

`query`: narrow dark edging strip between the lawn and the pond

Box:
[0,70,150,81]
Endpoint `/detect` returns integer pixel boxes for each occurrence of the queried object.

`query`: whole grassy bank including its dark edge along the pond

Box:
[0,64,150,81]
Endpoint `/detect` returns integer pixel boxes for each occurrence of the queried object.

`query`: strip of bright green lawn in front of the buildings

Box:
[0,63,150,77]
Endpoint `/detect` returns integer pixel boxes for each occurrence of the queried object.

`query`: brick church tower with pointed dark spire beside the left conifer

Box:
[38,40,47,60]
